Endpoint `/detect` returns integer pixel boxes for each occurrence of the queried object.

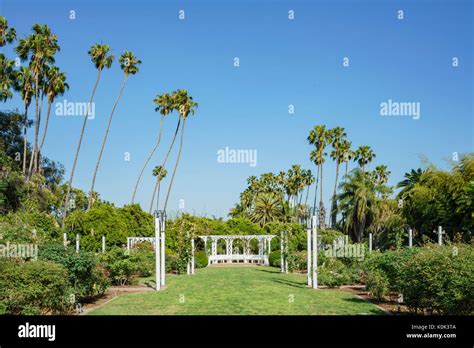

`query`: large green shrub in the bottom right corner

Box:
[364,244,474,314]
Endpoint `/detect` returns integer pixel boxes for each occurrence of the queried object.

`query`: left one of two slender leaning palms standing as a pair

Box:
[62,44,114,227]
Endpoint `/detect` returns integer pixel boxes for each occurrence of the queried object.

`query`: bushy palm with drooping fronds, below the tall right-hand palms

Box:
[338,169,377,243]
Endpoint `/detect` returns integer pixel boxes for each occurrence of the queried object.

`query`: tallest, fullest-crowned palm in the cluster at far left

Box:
[15,23,61,175]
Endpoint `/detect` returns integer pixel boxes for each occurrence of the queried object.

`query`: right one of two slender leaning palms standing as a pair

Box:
[87,51,141,210]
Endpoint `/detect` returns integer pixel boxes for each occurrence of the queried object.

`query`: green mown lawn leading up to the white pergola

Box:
[89,266,384,315]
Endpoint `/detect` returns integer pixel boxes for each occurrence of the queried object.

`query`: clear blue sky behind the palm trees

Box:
[0,0,474,217]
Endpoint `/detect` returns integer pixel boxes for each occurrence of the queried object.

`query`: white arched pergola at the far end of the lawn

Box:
[198,234,276,266]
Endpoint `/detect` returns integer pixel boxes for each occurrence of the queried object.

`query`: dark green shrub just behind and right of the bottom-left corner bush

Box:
[38,243,109,301]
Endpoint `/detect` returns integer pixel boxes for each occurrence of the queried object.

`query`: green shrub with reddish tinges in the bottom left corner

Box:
[0,260,72,315]
